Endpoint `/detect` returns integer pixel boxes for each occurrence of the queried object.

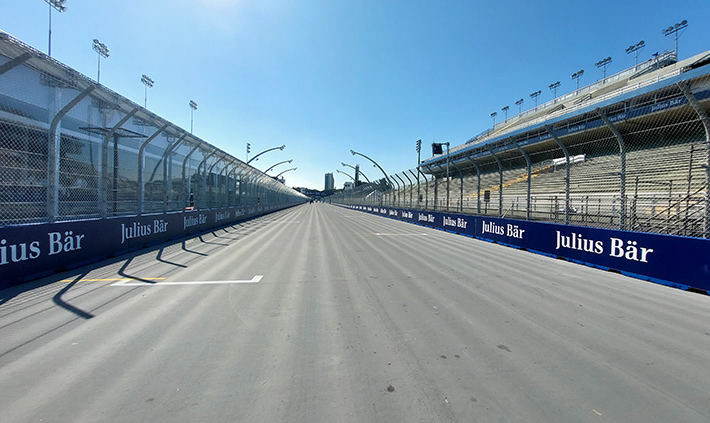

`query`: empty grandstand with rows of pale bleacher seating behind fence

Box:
[334,51,710,238]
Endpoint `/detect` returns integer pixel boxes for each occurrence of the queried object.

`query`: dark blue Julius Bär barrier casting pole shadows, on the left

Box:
[0,204,295,289]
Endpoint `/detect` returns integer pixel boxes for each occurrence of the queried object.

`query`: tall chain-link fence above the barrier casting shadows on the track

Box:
[0,32,306,226]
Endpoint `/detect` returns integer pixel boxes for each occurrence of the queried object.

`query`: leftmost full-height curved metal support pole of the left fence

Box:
[46,86,96,223]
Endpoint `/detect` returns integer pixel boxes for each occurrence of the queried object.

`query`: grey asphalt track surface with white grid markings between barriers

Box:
[0,204,710,423]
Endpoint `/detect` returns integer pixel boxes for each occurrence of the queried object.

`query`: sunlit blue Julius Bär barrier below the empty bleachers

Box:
[342,205,710,291]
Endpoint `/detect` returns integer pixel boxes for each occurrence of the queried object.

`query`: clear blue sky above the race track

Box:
[0,0,710,189]
